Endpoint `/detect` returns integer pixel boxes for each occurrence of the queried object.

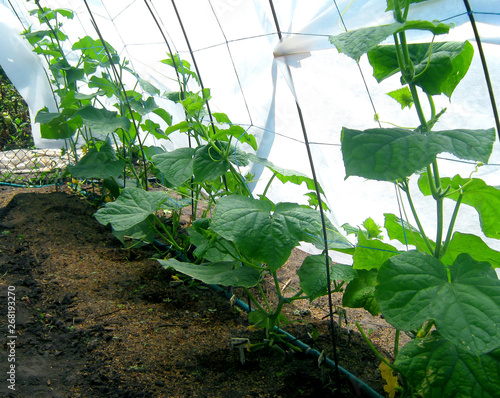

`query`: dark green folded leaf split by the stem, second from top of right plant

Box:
[368,42,474,97]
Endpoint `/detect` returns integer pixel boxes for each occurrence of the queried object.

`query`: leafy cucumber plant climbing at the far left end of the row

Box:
[23,1,172,192]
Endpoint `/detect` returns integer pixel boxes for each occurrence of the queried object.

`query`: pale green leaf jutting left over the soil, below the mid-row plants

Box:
[95,187,185,231]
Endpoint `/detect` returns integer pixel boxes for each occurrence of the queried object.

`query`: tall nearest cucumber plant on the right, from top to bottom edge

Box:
[330,0,500,397]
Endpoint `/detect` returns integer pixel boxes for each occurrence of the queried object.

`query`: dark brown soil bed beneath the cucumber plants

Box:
[0,187,400,398]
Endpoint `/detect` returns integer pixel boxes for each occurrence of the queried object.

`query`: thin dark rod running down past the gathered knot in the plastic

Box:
[269,0,340,382]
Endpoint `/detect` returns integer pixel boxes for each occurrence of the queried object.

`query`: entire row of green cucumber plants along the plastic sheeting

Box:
[24,0,500,397]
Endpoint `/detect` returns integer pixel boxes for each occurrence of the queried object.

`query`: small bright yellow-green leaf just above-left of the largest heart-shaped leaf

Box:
[352,233,399,270]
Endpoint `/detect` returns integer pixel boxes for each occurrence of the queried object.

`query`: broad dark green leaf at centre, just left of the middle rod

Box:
[211,195,328,271]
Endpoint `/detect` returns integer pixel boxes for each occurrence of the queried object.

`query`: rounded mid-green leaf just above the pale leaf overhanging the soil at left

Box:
[151,148,195,187]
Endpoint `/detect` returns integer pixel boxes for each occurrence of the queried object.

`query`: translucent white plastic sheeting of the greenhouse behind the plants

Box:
[0,0,500,268]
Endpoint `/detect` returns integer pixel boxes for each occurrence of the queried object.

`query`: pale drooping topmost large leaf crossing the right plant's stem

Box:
[330,21,450,61]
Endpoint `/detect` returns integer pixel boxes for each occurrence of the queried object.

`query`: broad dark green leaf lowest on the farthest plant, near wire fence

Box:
[68,142,125,179]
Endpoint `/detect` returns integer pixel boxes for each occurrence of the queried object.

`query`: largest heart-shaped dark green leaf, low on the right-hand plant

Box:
[375,252,500,355]
